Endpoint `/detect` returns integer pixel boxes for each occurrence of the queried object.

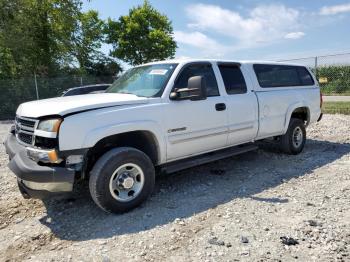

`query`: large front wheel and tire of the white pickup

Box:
[89,147,155,213]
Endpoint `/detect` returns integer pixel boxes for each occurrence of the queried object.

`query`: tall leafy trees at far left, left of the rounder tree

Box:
[0,0,121,118]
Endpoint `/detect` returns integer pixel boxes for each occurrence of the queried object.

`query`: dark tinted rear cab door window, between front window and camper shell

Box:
[219,65,247,95]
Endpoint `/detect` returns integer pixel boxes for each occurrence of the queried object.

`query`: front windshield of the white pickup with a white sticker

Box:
[106,64,177,97]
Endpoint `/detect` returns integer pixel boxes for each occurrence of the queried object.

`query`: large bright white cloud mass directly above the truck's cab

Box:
[174,3,305,58]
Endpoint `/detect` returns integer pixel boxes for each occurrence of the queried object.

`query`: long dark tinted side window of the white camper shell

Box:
[254,64,314,87]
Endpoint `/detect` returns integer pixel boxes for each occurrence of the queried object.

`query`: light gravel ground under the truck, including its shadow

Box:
[0,115,350,262]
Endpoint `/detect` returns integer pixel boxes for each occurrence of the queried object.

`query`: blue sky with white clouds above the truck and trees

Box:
[83,0,350,60]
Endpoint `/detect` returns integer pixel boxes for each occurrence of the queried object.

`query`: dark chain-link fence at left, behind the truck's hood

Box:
[0,75,114,120]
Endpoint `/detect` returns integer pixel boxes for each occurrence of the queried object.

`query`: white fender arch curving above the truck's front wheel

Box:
[82,120,166,163]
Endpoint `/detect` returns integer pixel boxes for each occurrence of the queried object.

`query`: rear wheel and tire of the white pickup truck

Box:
[281,118,306,155]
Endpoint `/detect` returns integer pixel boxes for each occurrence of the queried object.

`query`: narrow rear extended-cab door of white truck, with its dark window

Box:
[218,63,258,145]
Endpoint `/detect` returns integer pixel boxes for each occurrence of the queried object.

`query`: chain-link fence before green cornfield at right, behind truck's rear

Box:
[279,53,350,95]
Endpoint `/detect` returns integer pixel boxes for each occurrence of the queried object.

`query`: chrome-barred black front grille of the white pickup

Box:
[15,117,38,145]
